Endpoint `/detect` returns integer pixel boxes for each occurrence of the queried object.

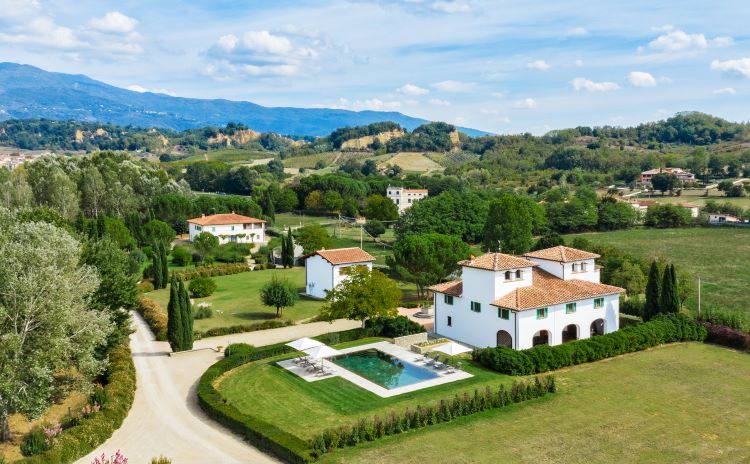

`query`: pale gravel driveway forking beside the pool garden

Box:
[78,313,359,464]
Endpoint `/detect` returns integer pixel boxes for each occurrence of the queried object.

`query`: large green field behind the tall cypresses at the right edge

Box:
[566,227,750,314]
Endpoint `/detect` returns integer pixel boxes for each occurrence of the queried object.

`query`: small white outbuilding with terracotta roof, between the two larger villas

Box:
[305,248,375,299]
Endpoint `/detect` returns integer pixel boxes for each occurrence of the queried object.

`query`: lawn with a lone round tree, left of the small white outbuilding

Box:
[147,267,323,331]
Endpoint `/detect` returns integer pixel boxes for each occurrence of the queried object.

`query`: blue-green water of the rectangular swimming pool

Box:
[331,348,438,389]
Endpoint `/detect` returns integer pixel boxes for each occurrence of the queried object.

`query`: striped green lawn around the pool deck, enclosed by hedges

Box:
[214,346,512,439]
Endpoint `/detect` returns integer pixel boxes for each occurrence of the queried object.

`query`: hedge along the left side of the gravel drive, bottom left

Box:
[17,341,135,464]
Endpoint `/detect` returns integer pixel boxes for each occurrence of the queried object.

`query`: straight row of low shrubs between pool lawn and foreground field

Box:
[310,375,557,457]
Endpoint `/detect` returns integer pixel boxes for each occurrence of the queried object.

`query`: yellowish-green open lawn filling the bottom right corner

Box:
[321,343,750,464]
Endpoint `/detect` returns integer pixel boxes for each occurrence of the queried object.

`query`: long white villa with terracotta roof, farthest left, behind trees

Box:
[188,211,266,245]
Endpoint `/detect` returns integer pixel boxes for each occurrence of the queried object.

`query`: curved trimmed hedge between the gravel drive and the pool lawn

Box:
[198,344,314,464]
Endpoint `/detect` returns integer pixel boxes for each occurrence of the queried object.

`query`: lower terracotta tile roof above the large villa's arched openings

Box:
[492,269,625,311]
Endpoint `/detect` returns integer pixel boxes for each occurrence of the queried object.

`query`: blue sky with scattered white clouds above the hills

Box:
[0,0,750,134]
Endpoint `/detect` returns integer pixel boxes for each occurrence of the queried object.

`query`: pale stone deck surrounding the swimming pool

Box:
[277,342,473,398]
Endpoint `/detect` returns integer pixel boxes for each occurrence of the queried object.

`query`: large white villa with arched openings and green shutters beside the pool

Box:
[430,246,625,350]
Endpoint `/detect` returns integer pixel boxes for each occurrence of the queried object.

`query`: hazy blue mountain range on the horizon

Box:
[0,62,486,136]
